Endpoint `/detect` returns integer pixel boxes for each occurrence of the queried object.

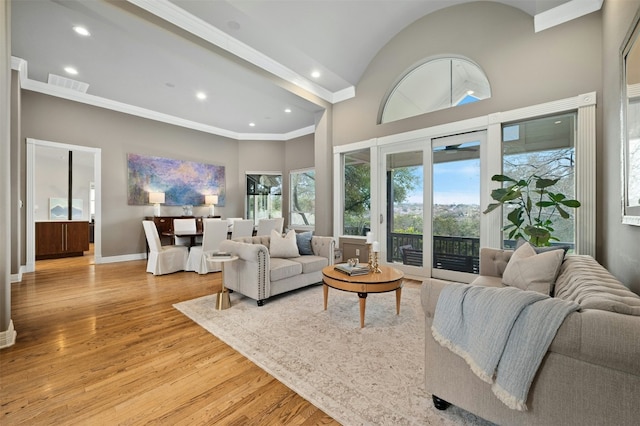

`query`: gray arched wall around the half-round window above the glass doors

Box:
[333,2,602,145]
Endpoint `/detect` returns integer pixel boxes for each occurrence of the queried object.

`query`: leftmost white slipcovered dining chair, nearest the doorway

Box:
[142,220,189,275]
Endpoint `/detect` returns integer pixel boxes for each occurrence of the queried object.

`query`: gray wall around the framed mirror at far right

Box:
[598,0,640,294]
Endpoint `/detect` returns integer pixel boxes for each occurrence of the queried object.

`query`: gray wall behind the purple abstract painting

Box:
[22,91,243,257]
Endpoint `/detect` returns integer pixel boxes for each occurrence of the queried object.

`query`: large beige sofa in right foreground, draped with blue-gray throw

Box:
[421,248,640,426]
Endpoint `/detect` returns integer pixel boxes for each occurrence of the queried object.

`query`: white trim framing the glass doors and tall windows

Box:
[333,92,596,257]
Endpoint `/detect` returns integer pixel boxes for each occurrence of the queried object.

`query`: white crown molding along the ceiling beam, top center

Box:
[127,0,355,104]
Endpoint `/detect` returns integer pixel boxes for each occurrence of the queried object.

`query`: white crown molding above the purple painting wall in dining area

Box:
[11,56,315,141]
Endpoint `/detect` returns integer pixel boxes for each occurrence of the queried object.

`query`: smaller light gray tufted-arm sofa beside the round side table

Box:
[220,235,335,306]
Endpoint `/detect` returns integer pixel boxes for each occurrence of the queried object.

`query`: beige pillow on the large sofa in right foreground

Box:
[502,244,564,294]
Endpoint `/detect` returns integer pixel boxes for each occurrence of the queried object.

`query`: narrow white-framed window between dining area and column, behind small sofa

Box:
[289,169,316,228]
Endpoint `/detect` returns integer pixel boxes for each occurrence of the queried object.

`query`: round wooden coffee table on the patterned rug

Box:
[322,265,404,328]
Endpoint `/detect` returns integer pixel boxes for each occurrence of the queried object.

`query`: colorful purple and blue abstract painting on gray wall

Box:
[127,154,225,207]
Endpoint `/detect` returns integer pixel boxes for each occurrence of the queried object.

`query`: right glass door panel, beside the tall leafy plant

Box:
[428,131,486,282]
